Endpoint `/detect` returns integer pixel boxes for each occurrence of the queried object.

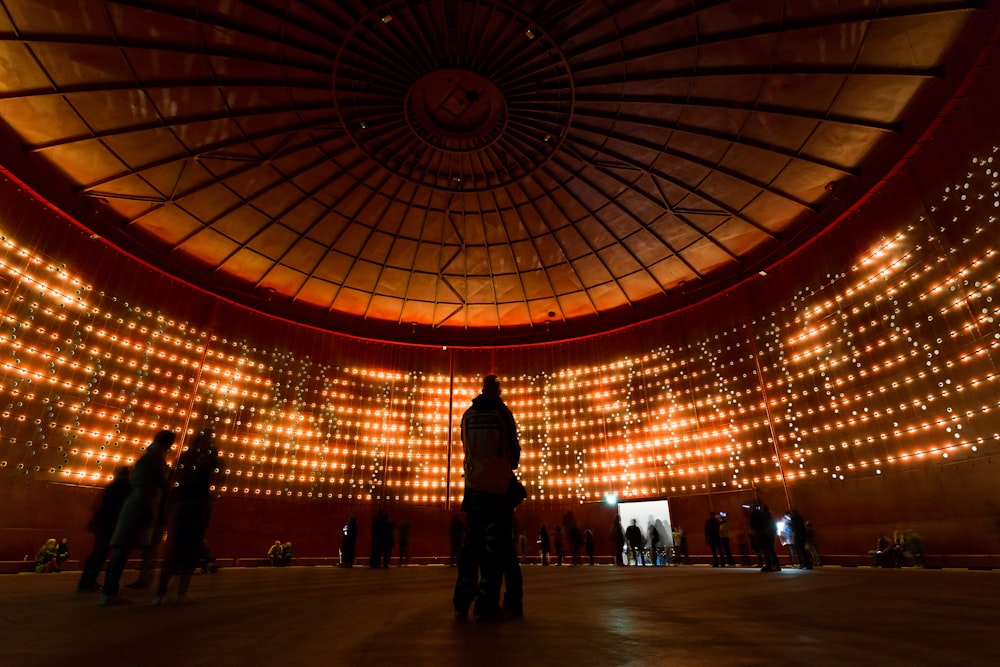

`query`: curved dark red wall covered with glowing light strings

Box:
[0,48,1000,563]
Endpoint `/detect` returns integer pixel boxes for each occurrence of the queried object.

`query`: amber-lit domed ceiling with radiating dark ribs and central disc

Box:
[0,0,996,345]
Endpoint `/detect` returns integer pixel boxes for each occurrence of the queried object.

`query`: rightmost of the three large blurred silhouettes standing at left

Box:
[153,430,219,605]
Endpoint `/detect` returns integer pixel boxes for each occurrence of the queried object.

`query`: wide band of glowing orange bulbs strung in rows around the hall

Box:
[0,150,1000,502]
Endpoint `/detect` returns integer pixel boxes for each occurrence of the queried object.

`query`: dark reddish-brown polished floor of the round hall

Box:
[0,565,1000,667]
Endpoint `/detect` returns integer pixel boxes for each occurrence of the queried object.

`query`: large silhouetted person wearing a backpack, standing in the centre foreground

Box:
[452,375,521,620]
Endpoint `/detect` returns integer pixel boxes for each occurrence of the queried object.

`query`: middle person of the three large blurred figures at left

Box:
[97,430,176,605]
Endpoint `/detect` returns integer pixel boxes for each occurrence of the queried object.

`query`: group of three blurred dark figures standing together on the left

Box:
[77,430,218,606]
